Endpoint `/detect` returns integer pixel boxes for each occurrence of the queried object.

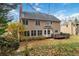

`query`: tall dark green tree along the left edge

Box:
[0,3,17,35]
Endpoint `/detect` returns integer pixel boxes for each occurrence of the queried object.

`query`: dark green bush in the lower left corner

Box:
[0,37,19,56]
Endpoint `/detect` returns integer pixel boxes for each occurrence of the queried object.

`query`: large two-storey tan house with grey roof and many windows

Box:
[21,12,60,37]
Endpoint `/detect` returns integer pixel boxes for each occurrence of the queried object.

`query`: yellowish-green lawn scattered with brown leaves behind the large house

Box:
[19,36,79,56]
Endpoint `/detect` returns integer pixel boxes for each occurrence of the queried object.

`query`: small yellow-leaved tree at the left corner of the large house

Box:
[7,22,25,39]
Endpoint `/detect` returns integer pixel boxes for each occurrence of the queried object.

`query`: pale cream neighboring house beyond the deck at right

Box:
[61,21,79,35]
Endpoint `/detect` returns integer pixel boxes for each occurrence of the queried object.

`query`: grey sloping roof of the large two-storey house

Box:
[22,12,60,22]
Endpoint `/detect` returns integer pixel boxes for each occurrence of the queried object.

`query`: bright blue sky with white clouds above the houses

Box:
[9,3,79,19]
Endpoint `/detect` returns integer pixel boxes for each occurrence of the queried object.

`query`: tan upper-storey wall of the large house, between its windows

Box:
[25,20,60,31]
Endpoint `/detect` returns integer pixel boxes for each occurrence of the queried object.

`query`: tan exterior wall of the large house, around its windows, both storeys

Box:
[21,20,60,37]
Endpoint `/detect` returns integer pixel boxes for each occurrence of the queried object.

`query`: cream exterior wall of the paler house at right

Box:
[60,22,76,35]
